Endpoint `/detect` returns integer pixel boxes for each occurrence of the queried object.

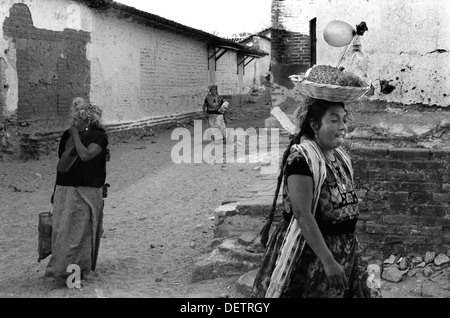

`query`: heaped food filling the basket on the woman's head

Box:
[305,65,367,87]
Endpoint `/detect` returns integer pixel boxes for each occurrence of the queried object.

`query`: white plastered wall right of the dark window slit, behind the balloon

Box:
[312,0,450,107]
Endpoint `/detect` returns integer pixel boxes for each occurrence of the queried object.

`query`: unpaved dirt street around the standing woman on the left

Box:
[0,95,269,298]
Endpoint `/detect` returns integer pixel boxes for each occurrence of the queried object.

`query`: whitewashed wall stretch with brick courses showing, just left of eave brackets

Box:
[140,30,208,115]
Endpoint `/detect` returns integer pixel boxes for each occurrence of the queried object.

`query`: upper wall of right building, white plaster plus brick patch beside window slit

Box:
[272,0,450,107]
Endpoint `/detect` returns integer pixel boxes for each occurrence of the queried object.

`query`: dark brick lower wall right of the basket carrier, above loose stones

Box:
[349,147,450,253]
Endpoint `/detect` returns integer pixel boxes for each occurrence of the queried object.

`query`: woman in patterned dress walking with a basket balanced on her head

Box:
[252,97,380,298]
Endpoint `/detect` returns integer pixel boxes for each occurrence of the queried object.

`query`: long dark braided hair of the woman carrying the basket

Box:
[261,97,345,247]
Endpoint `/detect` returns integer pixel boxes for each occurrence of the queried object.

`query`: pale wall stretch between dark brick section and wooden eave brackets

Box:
[88,9,209,123]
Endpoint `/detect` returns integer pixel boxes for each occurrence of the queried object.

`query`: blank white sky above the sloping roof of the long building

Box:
[115,0,272,38]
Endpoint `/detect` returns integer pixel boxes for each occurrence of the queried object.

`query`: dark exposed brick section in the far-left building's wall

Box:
[3,3,90,121]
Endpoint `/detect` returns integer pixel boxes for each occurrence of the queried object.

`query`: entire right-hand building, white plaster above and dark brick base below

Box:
[266,0,450,257]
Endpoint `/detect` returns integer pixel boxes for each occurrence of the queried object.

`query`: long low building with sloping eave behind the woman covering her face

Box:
[0,0,268,157]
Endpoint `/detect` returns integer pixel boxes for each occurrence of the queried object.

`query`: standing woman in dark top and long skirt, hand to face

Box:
[45,97,108,283]
